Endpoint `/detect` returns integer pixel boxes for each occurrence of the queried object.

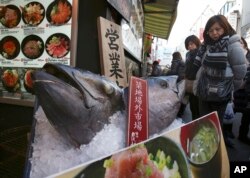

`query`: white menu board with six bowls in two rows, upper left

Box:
[0,0,72,68]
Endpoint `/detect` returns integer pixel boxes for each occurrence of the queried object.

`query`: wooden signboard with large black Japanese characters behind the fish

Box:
[97,17,128,87]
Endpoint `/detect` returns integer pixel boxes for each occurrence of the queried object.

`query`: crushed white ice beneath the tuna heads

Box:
[29,107,183,178]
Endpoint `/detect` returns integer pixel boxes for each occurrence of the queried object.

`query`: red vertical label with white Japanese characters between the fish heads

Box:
[127,76,148,146]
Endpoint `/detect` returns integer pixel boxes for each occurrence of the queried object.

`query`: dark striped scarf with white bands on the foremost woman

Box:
[194,36,229,70]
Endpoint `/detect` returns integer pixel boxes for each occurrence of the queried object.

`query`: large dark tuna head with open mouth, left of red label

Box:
[32,63,123,146]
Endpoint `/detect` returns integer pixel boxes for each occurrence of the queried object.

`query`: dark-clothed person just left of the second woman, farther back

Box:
[167,51,185,81]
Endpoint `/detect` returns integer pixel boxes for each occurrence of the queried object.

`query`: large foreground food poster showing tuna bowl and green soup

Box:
[46,112,230,178]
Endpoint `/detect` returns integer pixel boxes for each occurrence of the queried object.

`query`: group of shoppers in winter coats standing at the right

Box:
[146,15,250,147]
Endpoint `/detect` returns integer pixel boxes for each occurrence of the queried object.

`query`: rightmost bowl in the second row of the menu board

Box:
[45,33,70,58]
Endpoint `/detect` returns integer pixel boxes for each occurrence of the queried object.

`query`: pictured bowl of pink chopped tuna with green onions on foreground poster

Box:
[76,137,191,178]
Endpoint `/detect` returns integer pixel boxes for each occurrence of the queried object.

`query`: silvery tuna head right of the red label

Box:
[124,76,184,135]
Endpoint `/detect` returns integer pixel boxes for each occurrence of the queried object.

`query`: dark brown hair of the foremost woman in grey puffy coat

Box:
[203,15,236,44]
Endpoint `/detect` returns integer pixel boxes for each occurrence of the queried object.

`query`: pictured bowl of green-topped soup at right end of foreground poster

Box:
[180,114,222,177]
